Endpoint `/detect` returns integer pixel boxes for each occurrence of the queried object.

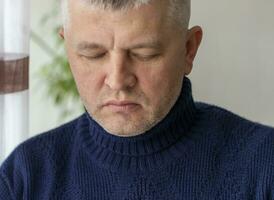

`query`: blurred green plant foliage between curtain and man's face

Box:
[31,1,84,118]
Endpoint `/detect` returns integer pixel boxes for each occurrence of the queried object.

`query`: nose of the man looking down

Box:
[105,55,137,91]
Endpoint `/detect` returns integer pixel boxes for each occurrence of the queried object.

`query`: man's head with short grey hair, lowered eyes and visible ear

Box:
[58,0,202,136]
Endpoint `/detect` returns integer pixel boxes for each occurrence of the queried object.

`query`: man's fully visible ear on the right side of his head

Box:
[185,26,203,75]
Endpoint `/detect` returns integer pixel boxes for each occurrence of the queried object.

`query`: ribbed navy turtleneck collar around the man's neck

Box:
[78,77,196,171]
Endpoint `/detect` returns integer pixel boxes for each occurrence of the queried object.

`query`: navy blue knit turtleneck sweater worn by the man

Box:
[0,78,274,200]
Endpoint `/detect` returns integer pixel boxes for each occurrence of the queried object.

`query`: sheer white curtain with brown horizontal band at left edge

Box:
[0,0,30,163]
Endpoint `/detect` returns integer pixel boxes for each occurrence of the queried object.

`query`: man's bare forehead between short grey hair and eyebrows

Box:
[68,0,176,48]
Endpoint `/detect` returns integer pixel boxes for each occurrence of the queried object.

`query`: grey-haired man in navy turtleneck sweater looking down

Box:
[0,0,274,200]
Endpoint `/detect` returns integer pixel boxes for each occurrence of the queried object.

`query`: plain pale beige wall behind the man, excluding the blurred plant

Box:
[30,0,274,135]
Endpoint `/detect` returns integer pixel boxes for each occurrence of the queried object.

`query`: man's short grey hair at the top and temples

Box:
[61,0,191,29]
